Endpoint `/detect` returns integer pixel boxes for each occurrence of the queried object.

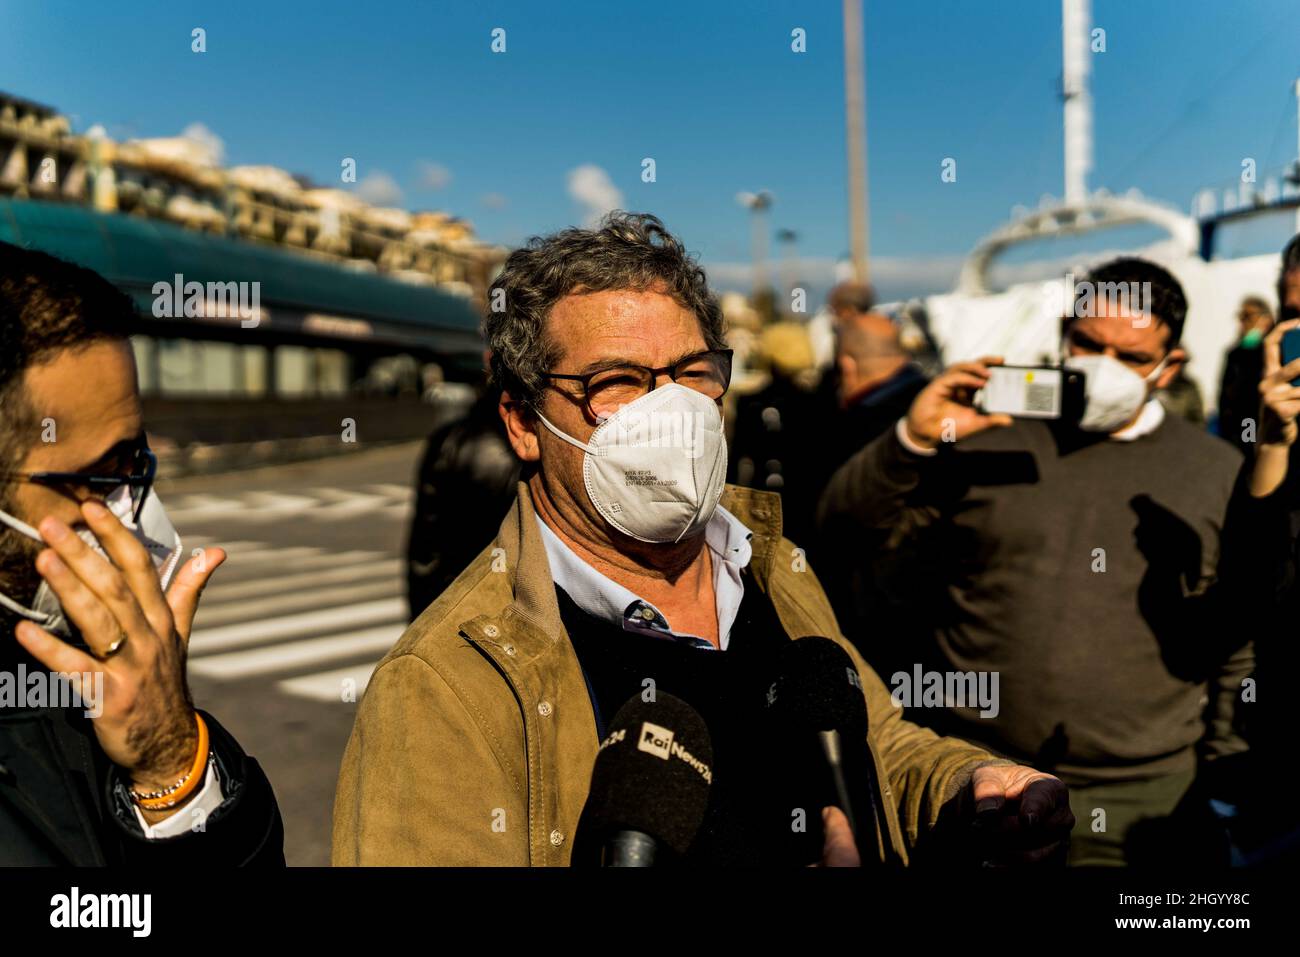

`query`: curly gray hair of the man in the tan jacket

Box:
[482,211,727,408]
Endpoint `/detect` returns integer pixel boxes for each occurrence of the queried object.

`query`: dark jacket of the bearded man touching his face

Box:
[0,647,285,874]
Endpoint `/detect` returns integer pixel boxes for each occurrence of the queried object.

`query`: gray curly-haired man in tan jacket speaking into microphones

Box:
[333,213,1073,866]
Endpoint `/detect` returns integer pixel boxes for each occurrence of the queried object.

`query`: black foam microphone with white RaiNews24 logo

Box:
[573,692,714,867]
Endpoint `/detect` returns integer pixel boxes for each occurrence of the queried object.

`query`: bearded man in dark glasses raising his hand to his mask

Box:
[0,243,283,867]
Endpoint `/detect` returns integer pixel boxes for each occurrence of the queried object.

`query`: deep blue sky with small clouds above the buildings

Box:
[0,0,1300,294]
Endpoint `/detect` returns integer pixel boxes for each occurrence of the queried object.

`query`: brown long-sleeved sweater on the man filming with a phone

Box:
[820,416,1253,784]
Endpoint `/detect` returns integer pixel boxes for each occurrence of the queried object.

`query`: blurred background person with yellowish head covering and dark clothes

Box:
[728,322,826,542]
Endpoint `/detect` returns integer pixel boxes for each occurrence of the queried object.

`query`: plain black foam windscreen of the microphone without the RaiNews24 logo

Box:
[767,636,867,740]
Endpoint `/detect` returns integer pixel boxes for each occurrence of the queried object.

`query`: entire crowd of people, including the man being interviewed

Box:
[0,213,1300,866]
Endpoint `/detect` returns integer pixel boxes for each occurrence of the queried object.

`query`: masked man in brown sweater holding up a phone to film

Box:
[819,259,1253,865]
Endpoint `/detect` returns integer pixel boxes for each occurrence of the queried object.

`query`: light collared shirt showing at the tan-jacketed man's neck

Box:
[537,506,753,651]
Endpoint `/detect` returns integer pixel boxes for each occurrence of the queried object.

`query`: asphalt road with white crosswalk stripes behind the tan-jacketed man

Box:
[157,442,421,865]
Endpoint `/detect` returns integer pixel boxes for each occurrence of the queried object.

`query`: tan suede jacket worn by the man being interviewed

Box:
[333,482,1001,866]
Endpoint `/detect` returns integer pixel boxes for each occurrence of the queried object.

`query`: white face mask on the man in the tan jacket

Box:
[537,382,727,542]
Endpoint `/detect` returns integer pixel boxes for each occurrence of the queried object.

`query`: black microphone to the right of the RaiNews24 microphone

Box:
[766,637,888,863]
